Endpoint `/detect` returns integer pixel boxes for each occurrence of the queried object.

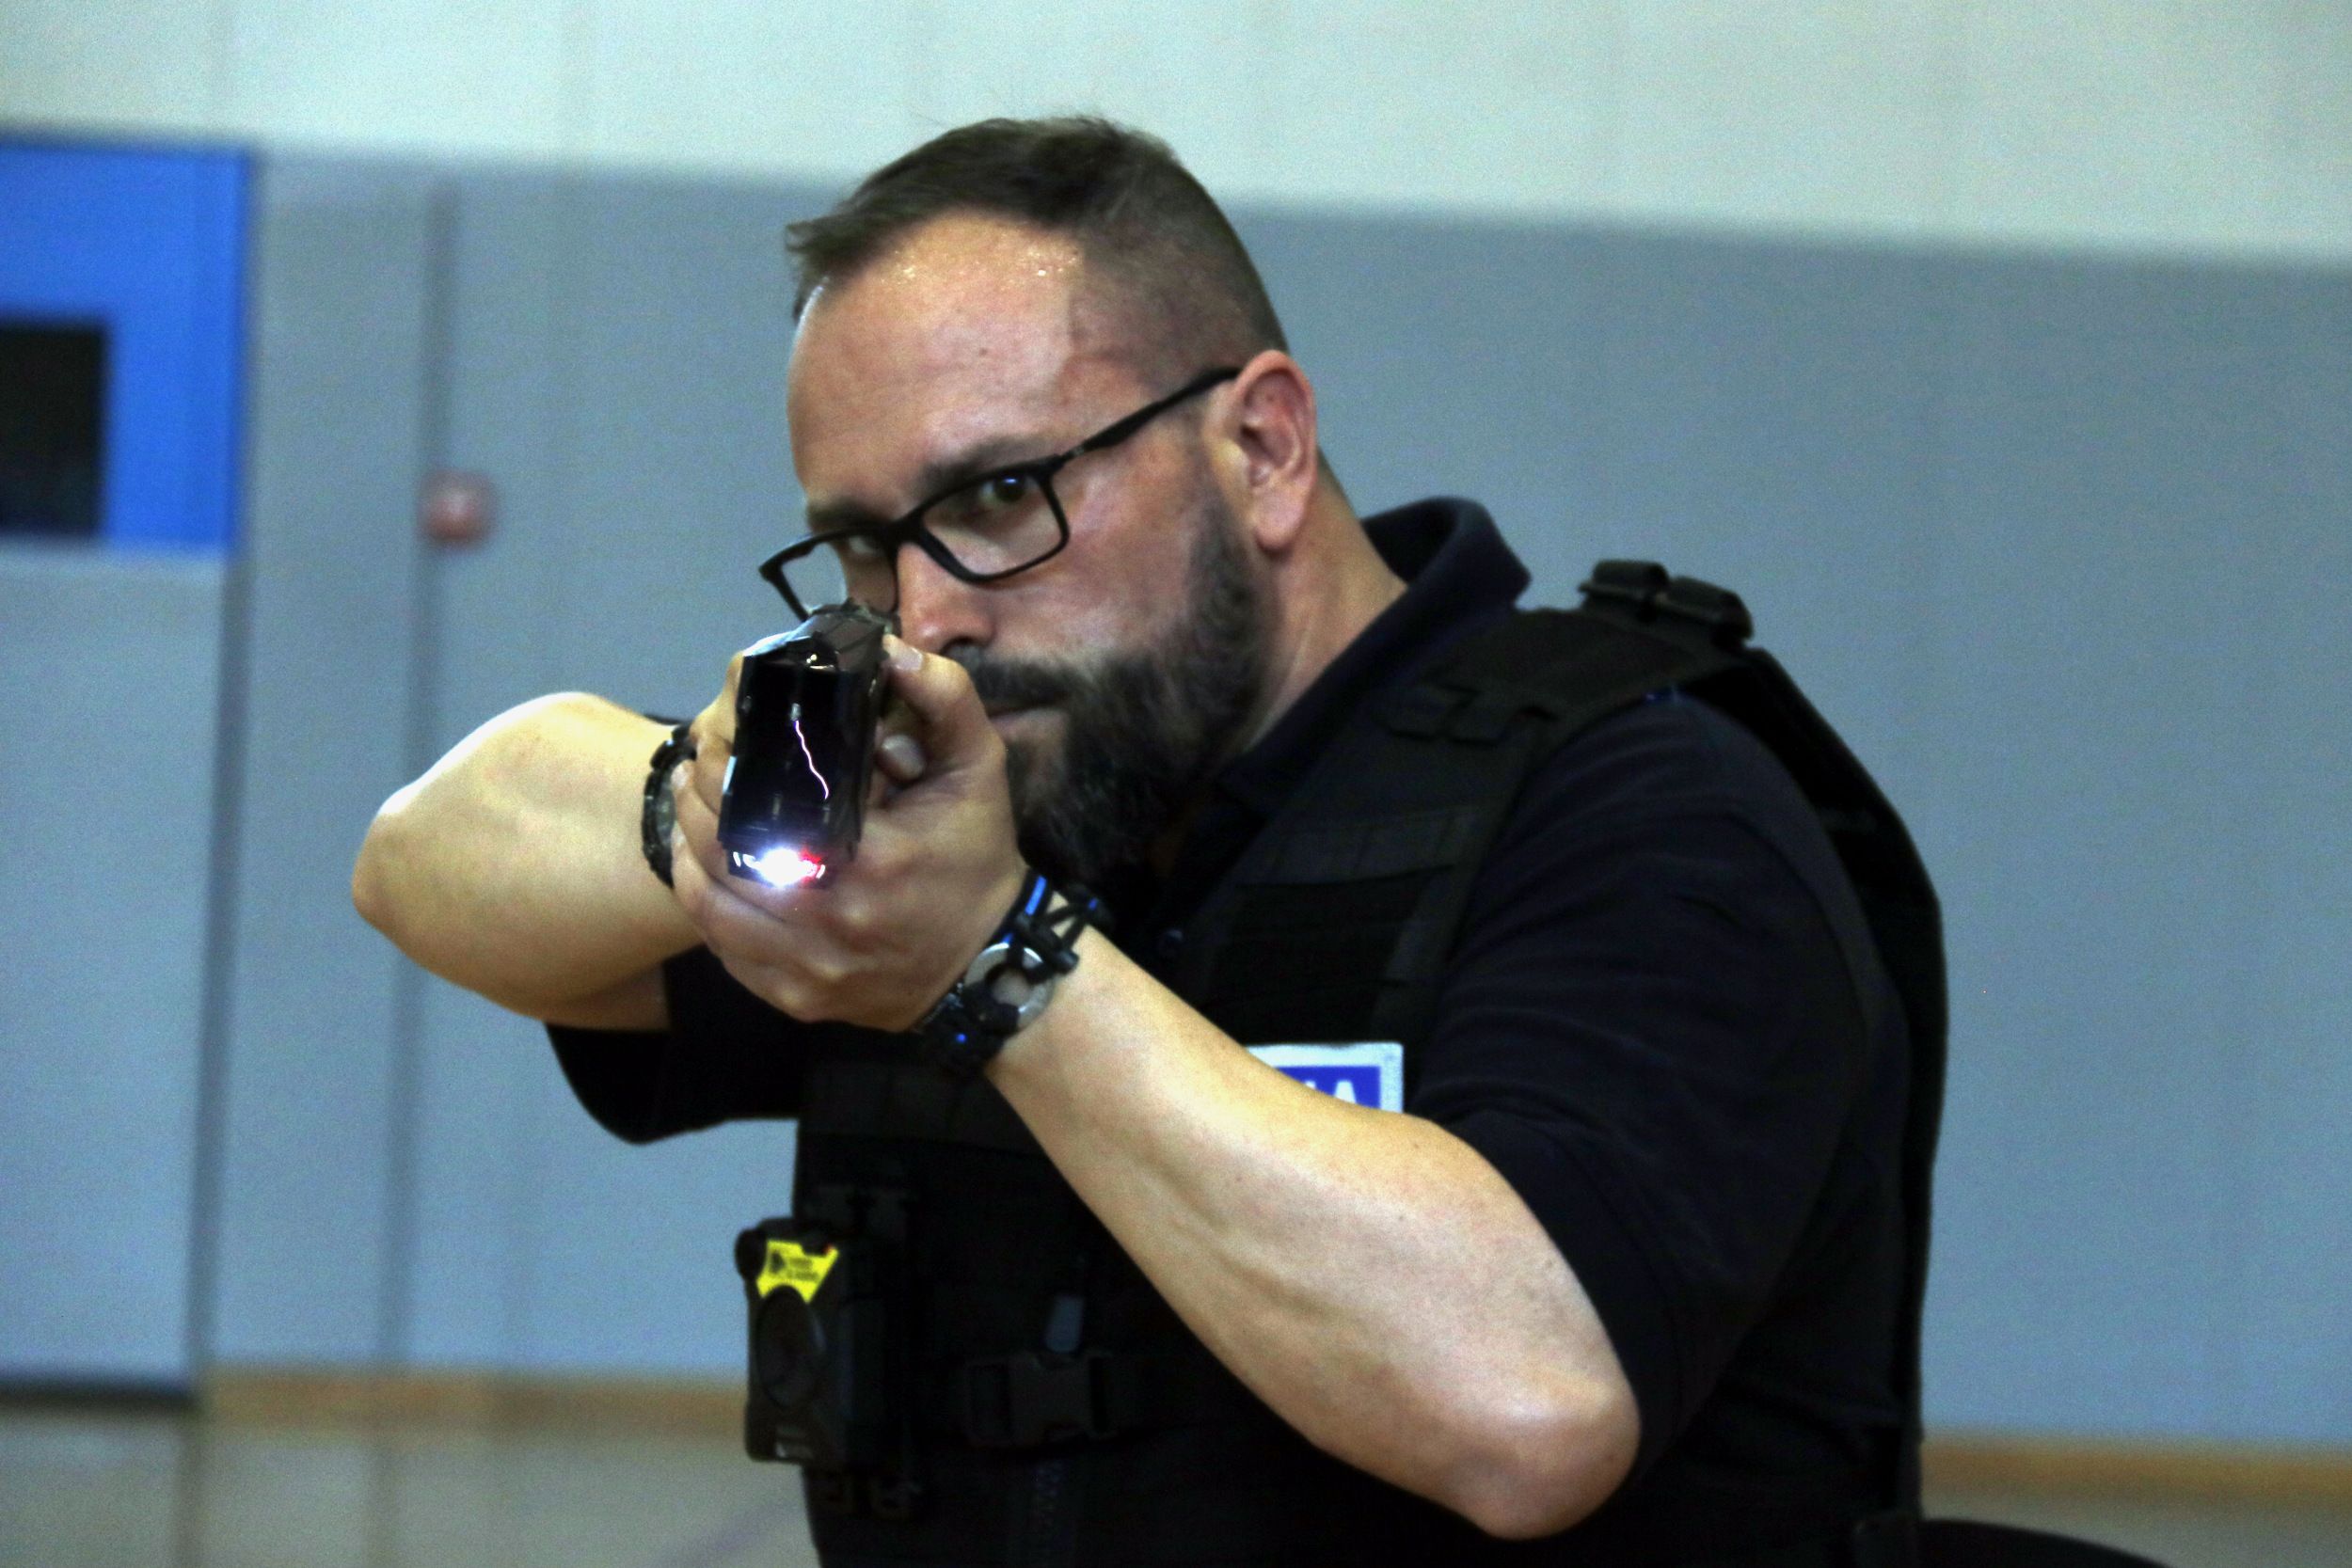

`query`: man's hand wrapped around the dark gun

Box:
[673,637,1021,1030]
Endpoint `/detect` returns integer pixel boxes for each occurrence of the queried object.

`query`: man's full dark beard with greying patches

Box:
[964,494,1265,886]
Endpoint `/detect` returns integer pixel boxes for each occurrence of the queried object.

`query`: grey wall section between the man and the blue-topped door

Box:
[212,160,828,1370]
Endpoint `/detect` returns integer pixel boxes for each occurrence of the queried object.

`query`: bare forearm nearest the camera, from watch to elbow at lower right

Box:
[993,936,1640,1535]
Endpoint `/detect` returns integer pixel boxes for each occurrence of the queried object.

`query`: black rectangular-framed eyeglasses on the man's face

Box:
[760,364,1242,618]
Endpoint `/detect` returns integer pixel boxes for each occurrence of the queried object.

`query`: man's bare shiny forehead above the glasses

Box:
[786,214,1132,500]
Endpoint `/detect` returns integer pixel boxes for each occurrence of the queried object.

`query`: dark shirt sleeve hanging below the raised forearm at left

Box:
[548,947,807,1143]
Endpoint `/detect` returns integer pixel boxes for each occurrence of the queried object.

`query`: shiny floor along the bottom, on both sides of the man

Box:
[0,1406,2352,1568]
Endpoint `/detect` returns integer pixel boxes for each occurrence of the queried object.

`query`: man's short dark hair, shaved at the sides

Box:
[786,115,1289,376]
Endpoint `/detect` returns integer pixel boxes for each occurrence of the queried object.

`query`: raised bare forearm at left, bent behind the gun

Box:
[351,693,699,1027]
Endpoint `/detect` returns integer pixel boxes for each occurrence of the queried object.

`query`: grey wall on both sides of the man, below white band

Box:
[13,150,2352,1441]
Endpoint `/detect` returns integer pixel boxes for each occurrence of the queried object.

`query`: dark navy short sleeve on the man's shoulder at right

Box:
[1409,698,1870,1472]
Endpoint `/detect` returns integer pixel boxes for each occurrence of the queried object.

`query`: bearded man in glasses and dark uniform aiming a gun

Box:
[356,119,1905,1563]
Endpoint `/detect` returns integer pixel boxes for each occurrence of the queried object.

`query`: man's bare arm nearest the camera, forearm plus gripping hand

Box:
[677,651,1640,1535]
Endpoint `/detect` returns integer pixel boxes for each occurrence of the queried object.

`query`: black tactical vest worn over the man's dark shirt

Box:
[795,562,1946,1563]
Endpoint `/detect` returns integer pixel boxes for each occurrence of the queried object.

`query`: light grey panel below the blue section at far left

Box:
[0,546,224,1385]
